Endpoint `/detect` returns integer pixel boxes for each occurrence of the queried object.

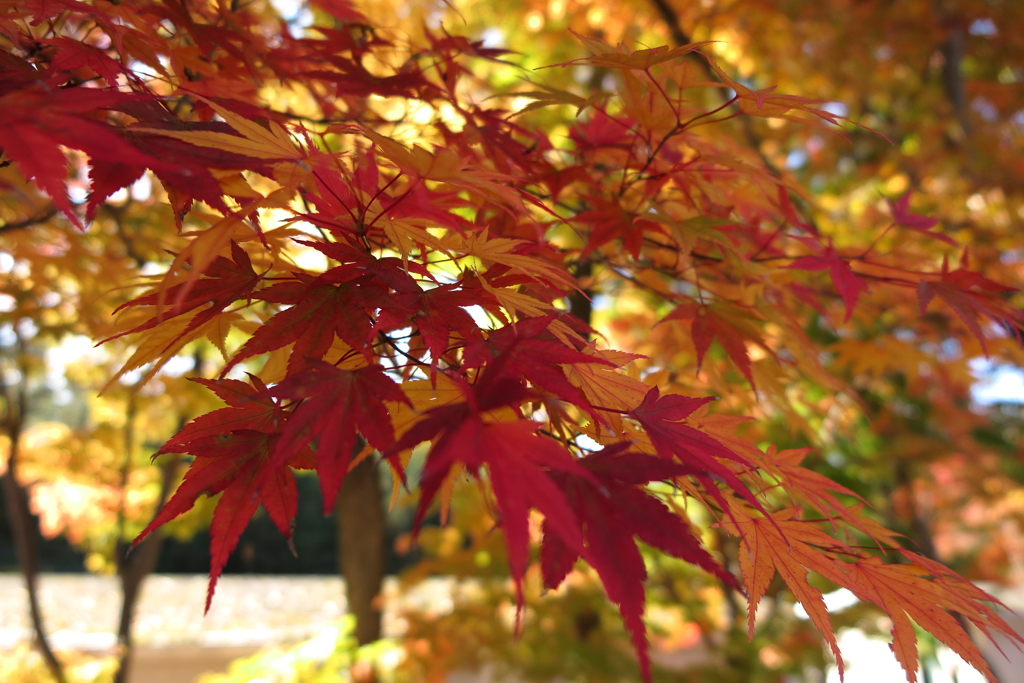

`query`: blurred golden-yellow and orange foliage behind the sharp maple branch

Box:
[0,0,1024,683]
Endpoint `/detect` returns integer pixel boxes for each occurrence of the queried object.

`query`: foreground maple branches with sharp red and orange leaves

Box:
[0,0,1024,681]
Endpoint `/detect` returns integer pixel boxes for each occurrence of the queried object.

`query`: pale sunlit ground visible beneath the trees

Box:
[0,573,1024,683]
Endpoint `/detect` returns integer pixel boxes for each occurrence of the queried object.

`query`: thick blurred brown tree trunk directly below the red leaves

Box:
[336,457,387,645]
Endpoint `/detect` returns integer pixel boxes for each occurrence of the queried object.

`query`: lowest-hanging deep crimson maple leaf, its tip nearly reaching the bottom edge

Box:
[541,443,740,681]
